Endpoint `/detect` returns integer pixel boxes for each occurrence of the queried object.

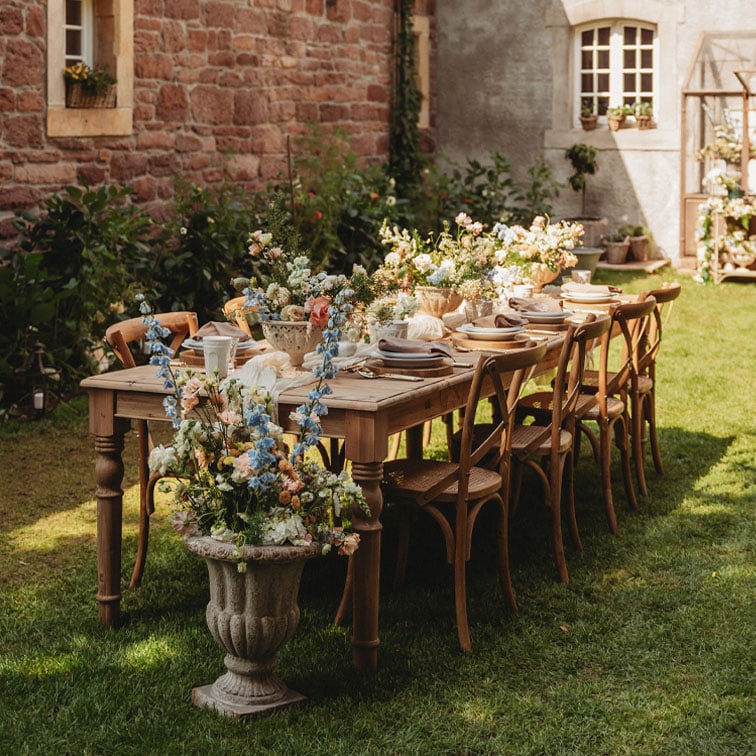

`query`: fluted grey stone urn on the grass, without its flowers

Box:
[184,536,321,719]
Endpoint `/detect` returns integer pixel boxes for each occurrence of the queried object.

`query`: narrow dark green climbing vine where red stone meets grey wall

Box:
[388,0,424,198]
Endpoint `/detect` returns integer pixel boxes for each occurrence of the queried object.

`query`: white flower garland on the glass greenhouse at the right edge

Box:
[696,196,756,283]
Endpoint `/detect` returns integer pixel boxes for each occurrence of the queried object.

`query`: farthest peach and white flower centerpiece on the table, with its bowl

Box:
[493,215,583,292]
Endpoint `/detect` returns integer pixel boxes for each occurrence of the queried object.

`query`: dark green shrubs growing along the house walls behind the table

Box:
[0,133,559,406]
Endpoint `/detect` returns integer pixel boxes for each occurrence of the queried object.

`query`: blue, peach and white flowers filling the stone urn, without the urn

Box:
[140,288,369,570]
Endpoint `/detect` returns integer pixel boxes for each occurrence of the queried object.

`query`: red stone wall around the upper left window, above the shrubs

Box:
[0,0,408,237]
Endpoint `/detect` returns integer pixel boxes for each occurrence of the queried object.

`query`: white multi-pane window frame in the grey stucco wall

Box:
[572,19,659,127]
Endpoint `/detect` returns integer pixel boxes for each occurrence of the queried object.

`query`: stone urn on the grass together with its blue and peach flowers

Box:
[140,289,369,717]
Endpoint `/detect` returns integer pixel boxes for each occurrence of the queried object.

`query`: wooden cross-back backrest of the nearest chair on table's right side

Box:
[423,343,547,501]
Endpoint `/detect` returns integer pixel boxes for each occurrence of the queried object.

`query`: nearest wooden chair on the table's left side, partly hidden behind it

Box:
[105,312,198,588]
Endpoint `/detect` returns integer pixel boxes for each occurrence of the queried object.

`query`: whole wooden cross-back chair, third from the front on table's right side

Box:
[574,295,656,533]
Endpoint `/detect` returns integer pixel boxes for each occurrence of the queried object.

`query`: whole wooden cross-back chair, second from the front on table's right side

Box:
[512,313,611,583]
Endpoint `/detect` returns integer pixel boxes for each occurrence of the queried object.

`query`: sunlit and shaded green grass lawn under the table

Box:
[0,270,756,756]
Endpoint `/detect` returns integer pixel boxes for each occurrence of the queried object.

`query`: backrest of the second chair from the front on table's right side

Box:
[523,313,612,454]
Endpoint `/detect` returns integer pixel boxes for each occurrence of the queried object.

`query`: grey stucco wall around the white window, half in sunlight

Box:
[437,0,756,258]
